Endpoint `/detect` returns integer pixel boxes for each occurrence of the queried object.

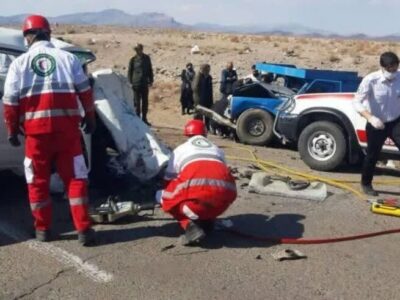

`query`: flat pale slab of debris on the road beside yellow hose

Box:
[249,172,328,201]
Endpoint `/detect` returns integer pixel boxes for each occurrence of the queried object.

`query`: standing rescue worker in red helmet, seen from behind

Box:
[3,15,95,246]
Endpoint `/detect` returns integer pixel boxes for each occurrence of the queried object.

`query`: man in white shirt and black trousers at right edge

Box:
[353,52,400,196]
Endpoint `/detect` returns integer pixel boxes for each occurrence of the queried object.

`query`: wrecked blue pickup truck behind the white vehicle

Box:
[227,63,361,145]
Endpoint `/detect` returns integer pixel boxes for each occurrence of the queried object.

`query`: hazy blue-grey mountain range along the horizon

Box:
[0,9,400,41]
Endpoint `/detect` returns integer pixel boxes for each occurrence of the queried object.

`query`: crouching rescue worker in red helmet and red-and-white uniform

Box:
[157,120,236,245]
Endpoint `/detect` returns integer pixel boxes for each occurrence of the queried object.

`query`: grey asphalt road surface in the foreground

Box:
[0,132,400,299]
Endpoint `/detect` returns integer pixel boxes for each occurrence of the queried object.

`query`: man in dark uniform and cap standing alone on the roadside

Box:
[128,44,154,126]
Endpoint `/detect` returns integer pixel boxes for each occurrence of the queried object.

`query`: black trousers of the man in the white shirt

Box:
[361,118,400,185]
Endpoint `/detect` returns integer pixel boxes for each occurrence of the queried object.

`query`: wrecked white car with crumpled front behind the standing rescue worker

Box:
[0,28,169,188]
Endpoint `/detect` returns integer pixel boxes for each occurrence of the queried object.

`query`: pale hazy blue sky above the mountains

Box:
[0,0,400,35]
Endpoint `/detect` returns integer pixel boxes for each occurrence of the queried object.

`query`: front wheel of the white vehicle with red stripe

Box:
[298,121,347,171]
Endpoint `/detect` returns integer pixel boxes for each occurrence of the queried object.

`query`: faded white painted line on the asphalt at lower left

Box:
[0,221,114,283]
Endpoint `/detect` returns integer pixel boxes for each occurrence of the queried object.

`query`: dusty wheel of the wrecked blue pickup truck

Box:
[236,109,274,146]
